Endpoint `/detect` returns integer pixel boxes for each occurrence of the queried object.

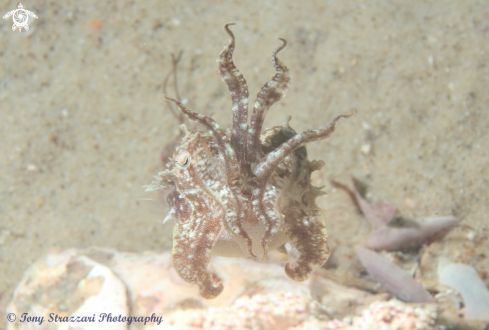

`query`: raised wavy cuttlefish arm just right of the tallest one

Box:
[246,38,291,166]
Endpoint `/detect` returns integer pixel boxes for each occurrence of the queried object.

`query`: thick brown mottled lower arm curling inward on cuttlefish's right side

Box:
[284,200,331,282]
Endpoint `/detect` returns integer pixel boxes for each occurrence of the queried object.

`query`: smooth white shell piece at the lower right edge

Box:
[438,262,489,321]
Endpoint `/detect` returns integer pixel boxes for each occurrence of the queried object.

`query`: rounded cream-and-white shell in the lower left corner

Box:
[7,250,129,330]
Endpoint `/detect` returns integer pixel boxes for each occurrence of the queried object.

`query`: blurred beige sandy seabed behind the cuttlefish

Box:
[0,0,489,328]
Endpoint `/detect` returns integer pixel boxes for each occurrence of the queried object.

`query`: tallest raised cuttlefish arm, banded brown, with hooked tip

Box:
[217,23,250,174]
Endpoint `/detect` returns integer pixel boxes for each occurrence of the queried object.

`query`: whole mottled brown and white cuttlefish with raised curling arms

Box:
[147,24,351,299]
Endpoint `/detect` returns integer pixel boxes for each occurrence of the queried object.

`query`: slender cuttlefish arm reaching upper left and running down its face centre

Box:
[165,95,255,256]
